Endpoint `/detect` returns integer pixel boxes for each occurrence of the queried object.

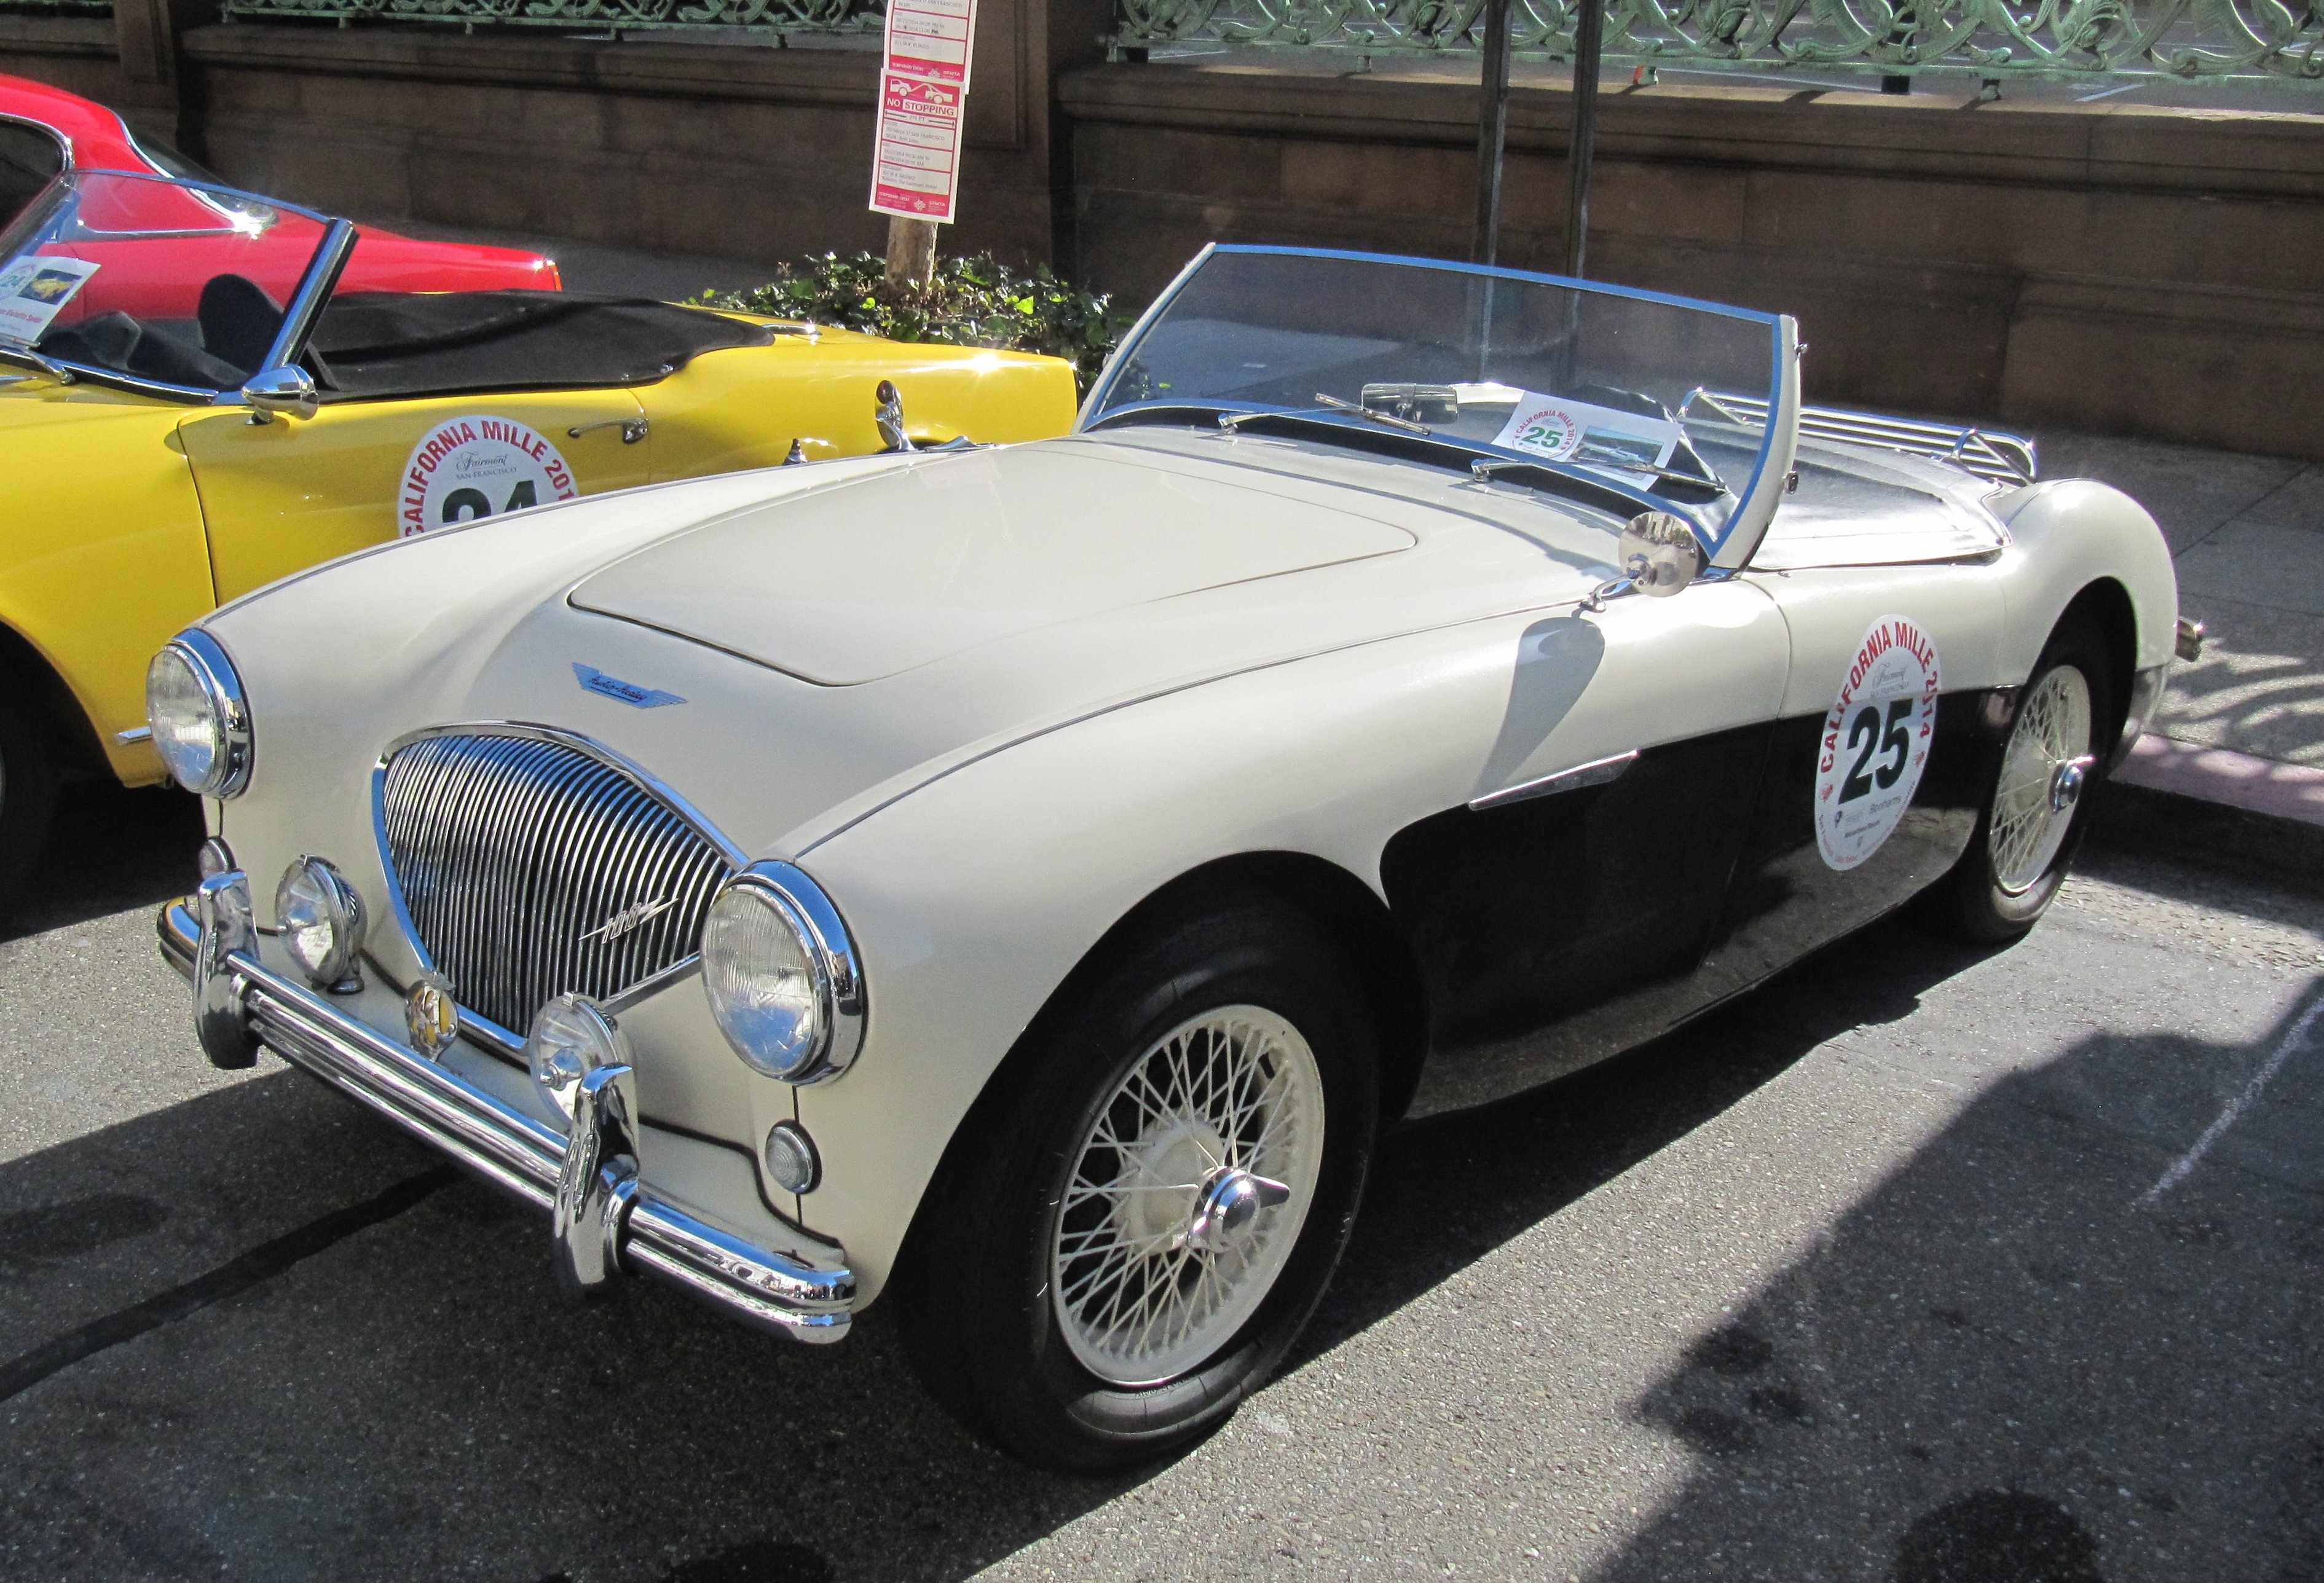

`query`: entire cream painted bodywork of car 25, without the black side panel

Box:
[207,430,2175,1302]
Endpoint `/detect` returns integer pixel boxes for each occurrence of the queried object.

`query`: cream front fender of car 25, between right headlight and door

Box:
[795,586,1782,1295]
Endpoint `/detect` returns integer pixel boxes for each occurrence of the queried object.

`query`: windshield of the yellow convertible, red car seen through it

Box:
[0,170,328,393]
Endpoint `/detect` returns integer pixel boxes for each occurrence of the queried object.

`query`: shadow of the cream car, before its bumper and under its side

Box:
[0,876,1975,1583]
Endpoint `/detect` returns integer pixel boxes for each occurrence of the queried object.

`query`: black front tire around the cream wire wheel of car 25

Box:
[892,900,1378,1471]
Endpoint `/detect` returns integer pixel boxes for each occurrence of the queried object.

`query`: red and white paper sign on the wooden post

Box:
[872,0,976,223]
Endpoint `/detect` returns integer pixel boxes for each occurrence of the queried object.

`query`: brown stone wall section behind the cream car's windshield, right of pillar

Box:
[1060,65,2324,455]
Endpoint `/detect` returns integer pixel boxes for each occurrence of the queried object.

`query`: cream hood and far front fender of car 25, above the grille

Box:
[207,430,1615,872]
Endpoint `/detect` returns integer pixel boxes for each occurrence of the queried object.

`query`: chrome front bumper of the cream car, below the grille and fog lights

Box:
[156,887,855,1341]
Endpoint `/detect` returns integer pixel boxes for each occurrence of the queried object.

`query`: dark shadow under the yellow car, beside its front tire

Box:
[0,781,202,941]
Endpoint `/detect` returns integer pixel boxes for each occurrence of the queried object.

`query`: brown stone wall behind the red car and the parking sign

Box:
[0,0,1109,261]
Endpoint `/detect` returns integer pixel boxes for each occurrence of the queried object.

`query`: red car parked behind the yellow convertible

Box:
[0,77,562,293]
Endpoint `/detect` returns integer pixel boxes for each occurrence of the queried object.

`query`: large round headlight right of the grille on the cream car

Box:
[702,862,862,1083]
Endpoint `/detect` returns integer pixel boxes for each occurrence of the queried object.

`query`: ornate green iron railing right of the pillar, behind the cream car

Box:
[1109,0,2324,84]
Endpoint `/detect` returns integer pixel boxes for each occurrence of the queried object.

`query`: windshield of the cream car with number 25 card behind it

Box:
[1081,246,1797,560]
